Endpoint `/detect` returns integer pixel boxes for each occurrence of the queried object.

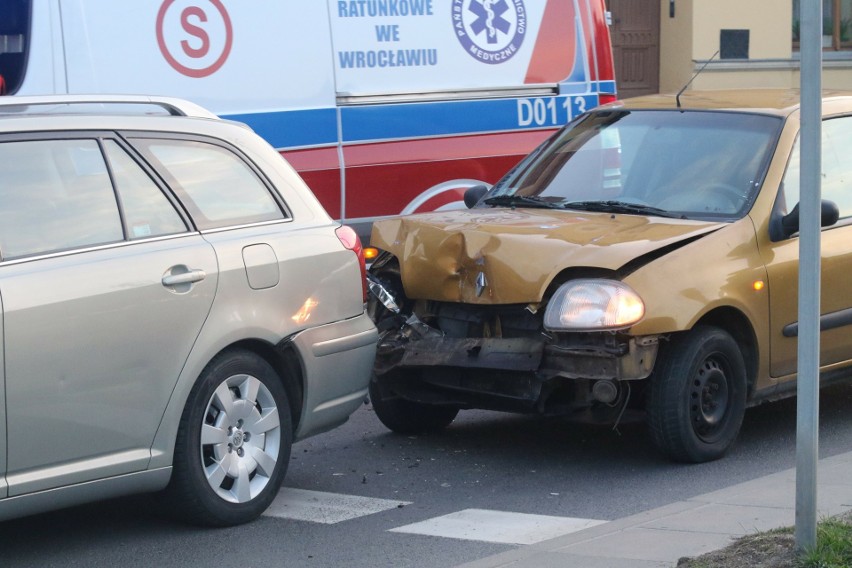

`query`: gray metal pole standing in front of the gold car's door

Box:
[796,0,822,552]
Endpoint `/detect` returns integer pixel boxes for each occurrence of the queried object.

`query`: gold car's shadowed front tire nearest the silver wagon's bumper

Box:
[370,377,459,434]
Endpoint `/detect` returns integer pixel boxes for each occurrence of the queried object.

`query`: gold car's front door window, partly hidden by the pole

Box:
[783,117,852,219]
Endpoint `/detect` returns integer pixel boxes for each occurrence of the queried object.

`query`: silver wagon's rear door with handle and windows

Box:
[0,133,217,496]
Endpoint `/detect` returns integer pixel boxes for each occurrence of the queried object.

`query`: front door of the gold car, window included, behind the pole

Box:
[766,117,852,378]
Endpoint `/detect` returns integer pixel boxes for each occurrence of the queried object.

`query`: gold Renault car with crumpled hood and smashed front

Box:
[369,90,852,462]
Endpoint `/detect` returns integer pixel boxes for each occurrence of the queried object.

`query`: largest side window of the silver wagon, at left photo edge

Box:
[0,140,124,259]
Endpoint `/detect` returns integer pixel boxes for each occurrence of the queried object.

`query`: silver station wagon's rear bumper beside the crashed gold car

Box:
[291,314,378,440]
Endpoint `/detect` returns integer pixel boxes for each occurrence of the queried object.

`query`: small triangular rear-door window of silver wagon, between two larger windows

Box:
[104,140,187,239]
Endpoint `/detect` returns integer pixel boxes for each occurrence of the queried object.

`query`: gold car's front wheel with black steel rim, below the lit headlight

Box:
[647,326,747,463]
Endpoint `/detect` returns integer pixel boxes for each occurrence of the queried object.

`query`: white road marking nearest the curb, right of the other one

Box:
[390,509,607,544]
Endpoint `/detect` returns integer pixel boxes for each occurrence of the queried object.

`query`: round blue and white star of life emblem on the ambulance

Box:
[452,0,527,65]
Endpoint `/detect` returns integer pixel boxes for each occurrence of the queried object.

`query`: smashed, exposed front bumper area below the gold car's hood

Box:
[368,253,658,429]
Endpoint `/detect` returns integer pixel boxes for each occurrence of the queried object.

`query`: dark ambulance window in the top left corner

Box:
[0,0,30,95]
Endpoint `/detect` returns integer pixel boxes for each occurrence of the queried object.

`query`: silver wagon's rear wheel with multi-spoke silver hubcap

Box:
[164,350,293,527]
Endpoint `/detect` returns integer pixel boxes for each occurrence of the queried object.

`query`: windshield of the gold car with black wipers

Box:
[490,110,782,219]
